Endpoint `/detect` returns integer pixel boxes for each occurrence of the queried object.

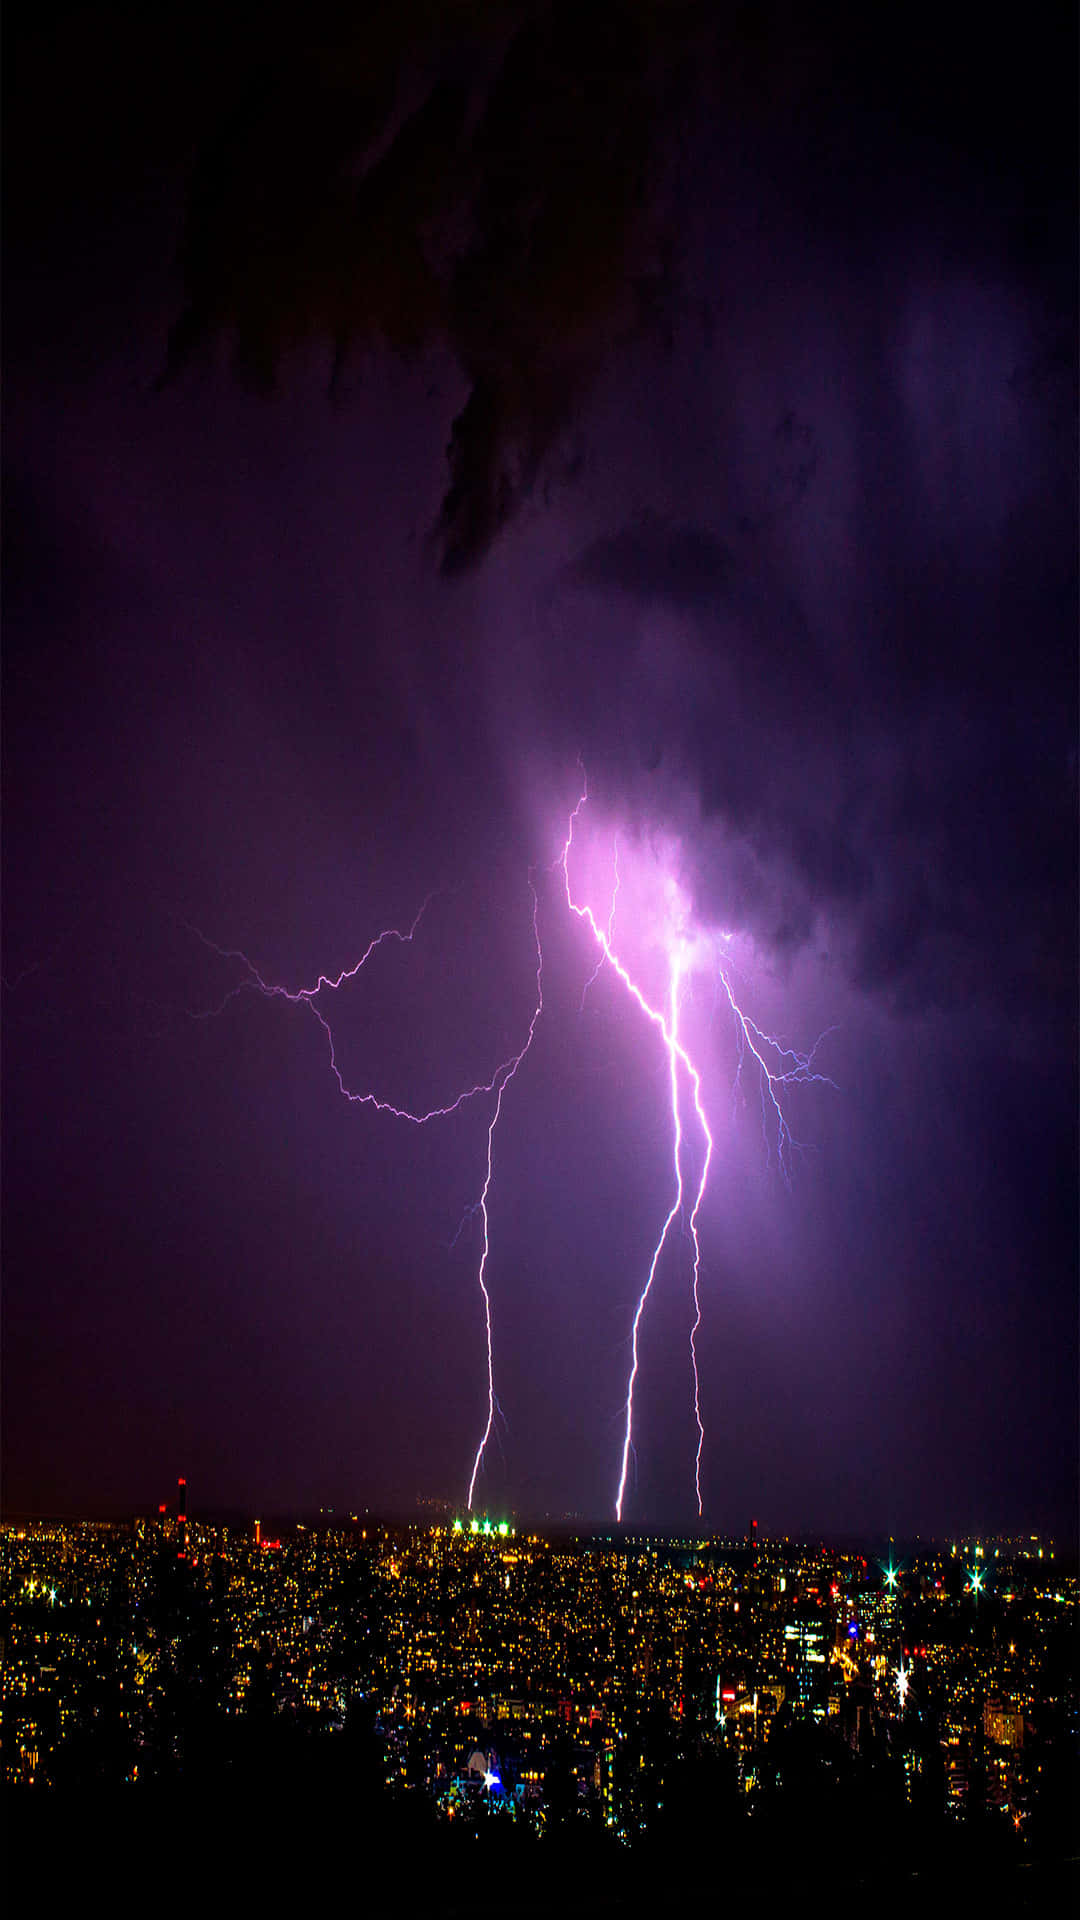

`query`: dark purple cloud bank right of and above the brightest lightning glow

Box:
[567,408,1076,1021]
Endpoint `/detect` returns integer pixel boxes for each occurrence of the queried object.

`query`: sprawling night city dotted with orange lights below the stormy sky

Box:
[0,1482,1080,1893]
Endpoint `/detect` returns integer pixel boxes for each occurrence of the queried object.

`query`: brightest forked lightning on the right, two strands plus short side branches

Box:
[557,768,834,1521]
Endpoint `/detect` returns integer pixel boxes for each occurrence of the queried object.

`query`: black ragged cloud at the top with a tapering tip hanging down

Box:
[159,6,682,574]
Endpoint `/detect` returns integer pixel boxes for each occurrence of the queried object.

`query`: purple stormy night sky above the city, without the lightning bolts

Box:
[2,0,1078,1538]
